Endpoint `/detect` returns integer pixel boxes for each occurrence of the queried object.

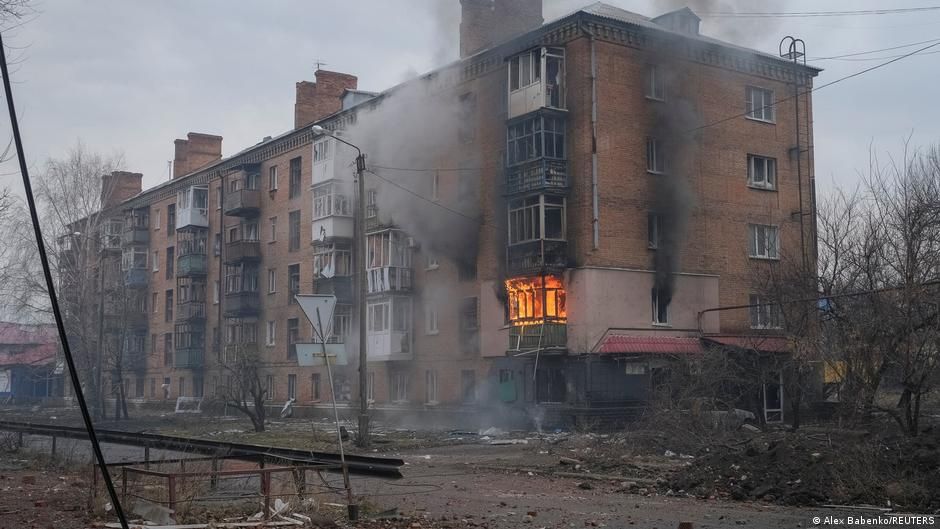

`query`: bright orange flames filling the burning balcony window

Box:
[506,276,568,325]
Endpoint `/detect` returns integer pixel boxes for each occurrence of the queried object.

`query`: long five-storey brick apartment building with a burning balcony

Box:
[62,0,818,424]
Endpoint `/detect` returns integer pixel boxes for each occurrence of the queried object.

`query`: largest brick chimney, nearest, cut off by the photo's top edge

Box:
[460,0,544,58]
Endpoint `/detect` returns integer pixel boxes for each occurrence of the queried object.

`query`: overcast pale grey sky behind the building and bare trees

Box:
[0,0,940,196]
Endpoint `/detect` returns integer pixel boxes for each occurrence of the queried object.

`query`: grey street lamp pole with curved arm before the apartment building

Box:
[310,125,369,448]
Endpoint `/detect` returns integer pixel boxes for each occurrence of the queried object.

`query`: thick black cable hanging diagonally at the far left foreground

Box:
[0,29,129,529]
